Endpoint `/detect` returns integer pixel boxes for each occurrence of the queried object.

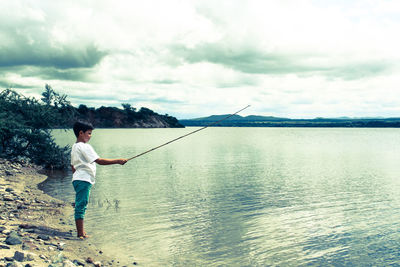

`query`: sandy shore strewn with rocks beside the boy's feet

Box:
[0,159,138,267]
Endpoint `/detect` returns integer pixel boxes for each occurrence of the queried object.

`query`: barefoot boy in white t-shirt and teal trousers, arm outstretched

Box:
[71,121,127,239]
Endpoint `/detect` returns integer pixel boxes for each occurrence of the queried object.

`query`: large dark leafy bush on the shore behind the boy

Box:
[0,85,75,169]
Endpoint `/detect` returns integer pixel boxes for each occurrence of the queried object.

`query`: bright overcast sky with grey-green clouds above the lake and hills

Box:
[0,0,400,119]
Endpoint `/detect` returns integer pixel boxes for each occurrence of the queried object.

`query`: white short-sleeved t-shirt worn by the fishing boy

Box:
[71,142,99,184]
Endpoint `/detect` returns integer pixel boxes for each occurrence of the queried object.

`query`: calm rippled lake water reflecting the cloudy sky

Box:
[43,128,400,266]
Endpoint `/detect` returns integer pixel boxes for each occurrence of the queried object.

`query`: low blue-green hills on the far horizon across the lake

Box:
[179,115,400,128]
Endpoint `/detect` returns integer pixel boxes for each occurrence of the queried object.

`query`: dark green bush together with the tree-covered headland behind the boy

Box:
[0,85,183,169]
